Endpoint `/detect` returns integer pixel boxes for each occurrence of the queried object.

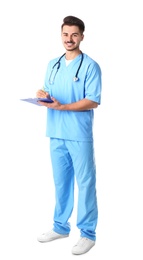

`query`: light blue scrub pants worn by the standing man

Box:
[50,138,98,240]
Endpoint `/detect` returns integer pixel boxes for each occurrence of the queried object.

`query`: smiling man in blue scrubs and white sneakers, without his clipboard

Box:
[36,16,101,254]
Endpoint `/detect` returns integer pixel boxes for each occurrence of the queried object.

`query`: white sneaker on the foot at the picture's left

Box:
[37,230,69,243]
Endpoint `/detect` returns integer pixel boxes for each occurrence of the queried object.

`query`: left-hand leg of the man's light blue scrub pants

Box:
[50,138,74,234]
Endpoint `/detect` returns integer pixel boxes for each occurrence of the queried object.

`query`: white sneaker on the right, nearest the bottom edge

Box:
[72,237,95,255]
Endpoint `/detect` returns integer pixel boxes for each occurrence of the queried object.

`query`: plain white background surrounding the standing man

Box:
[0,0,143,260]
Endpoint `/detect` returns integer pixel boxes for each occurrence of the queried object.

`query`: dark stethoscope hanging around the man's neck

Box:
[49,52,83,85]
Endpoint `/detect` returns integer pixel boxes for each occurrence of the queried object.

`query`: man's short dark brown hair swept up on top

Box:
[61,15,85,33]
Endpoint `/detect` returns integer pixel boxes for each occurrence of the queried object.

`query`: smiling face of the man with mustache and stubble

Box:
[61,25,84,51]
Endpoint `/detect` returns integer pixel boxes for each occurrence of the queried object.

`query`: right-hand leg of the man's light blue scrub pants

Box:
[66,141,98,240]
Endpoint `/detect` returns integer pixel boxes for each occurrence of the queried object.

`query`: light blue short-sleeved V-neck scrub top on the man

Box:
[44,53,101,141]
